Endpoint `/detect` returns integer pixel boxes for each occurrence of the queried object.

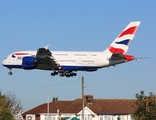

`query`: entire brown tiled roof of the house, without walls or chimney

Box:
[22,96,136,115]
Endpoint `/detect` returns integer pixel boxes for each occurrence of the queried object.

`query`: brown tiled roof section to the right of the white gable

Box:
[89,99,136,114]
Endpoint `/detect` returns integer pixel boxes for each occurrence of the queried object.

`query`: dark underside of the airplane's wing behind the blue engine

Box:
[36,46,59,70]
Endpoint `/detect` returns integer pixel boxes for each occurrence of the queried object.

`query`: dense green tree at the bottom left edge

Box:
[0,91,13,120]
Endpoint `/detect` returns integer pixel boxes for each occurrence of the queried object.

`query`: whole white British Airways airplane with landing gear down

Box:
[2,21,141,77]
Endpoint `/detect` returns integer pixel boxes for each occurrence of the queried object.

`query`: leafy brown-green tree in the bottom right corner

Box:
[132,91,156,120]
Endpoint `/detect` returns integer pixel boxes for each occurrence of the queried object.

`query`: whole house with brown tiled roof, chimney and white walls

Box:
[22,95,136,120]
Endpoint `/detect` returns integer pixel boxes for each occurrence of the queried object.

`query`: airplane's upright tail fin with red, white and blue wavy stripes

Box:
[105,21,141,55]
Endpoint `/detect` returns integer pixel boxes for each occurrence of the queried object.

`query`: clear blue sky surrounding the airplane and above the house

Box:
[0,0,156,110]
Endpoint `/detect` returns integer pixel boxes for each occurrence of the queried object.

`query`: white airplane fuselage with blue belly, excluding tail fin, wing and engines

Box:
[2,51,125,71]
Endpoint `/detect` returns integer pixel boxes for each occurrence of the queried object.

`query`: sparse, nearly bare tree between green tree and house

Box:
[6,91,23,117]
